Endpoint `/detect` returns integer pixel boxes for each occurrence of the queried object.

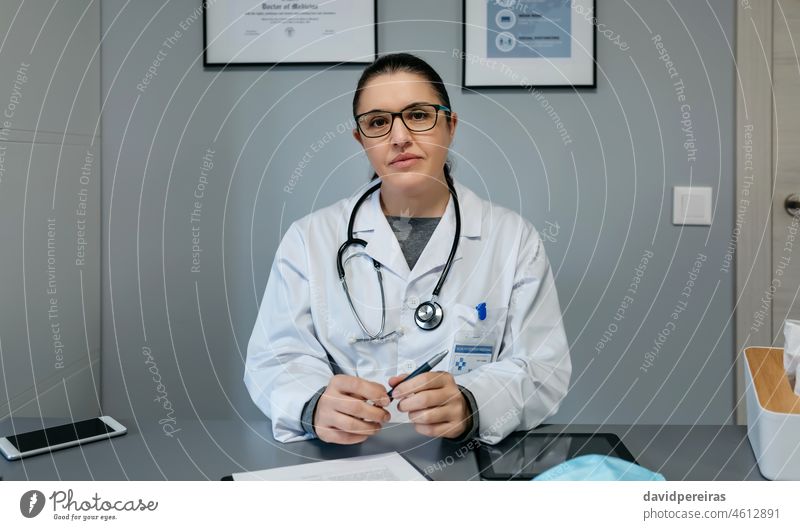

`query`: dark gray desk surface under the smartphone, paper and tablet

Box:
[0,418,763,480]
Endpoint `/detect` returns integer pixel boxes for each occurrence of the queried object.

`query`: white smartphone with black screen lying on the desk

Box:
[0,416,128,460]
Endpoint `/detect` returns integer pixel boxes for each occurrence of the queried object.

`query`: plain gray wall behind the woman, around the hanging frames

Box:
[102,0,735,428]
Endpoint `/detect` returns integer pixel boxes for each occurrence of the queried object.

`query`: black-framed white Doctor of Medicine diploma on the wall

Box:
[203,0,378,66]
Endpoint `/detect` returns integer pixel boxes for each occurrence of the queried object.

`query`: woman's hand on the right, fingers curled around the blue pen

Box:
[389,372,472,438]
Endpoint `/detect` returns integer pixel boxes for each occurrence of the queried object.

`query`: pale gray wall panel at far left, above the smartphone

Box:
[0,0,101,420]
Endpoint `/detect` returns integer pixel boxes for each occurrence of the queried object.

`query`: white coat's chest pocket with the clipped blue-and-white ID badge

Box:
[448,304,508,375]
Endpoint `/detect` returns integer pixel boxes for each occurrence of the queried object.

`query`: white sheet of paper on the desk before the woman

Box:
[233,452,427,480]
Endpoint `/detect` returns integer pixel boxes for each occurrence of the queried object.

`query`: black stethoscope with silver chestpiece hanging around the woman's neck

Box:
[336,169,461,342]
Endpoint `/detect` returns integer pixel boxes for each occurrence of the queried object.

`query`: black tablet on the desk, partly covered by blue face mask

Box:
[478,432,636,480]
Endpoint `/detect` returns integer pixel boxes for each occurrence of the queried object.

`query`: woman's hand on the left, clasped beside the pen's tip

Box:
[314,374,391,444]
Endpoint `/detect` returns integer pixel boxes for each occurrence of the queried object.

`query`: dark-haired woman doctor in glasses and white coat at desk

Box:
[244,54,571,444]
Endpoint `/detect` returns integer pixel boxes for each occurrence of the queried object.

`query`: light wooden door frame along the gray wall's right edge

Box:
[729,0,774,425]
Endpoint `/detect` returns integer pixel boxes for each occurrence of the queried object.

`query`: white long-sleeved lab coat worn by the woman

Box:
[244,179,572,444]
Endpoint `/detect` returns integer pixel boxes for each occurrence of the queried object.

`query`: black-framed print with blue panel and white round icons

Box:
[461,0,597,88]
